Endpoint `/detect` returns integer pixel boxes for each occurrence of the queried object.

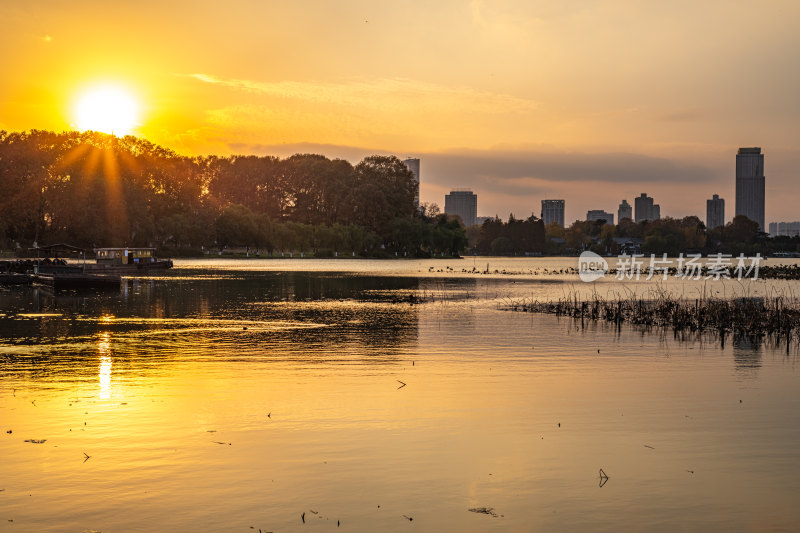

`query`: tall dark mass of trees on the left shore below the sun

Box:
[0,130,466,257]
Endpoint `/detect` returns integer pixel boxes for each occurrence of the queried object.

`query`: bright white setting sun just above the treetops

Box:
[75,85,138,136]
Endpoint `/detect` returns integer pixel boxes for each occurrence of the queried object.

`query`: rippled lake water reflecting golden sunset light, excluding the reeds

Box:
[0,258,800,533]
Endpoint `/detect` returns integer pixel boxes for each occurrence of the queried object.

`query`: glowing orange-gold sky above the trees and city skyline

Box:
[0,0,800,222]
